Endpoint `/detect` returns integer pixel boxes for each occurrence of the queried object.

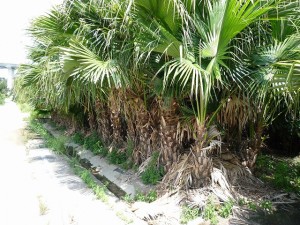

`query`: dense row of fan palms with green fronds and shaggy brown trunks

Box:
[15,0,300,187]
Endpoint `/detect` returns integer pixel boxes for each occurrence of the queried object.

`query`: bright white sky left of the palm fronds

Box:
[0,0,63,64]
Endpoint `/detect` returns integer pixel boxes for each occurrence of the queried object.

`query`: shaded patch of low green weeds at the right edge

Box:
[255,155,300,194]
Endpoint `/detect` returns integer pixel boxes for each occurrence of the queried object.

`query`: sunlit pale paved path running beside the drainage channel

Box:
[0,101,125,225]
